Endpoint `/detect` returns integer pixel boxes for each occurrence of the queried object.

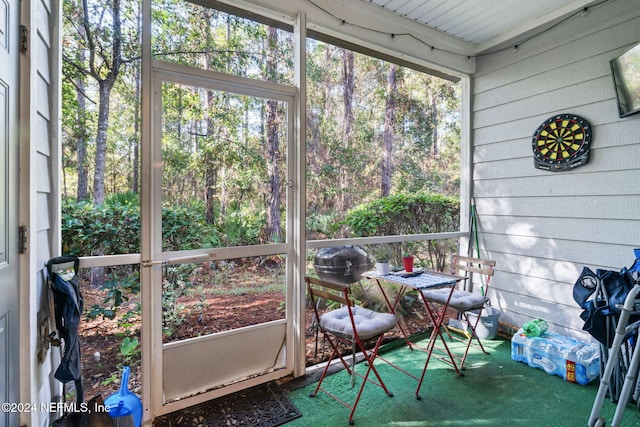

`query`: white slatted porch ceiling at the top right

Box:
[357,0,603,54]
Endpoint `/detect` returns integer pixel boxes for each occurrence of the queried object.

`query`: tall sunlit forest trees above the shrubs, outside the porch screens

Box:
[62,0,460,246]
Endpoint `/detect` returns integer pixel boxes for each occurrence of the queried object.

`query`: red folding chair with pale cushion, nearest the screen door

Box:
[305,277,398,424]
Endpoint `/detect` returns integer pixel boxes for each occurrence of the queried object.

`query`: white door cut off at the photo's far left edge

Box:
[0,0,20,427]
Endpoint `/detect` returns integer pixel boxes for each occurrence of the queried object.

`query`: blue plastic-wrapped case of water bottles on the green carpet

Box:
[511,328,600,385]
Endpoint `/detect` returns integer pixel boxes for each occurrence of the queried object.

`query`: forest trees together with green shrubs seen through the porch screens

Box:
[61,0,460,392]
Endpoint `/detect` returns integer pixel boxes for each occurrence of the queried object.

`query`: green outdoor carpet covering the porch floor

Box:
[286,338,640,427]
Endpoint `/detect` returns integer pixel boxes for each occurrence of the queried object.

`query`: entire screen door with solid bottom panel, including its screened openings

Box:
[148,63,304,415]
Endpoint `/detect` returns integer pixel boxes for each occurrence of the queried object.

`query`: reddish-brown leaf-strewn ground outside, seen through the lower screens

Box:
[76,272,431,399]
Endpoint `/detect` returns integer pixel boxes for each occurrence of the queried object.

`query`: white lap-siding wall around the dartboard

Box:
[472,0,640,339]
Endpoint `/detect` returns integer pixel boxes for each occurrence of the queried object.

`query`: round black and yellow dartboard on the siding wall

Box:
[533,114,592,172]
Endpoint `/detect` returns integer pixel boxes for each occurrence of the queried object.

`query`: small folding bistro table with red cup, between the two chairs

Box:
[363,269,466,399]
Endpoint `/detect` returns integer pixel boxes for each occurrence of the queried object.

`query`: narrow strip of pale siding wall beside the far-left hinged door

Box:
[20,0,61,426]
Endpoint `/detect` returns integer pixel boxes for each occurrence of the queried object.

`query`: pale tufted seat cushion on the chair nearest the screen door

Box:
[320,306,398,340]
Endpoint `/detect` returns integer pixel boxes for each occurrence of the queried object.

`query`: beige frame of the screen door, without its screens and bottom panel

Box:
[141,61,305,418]
